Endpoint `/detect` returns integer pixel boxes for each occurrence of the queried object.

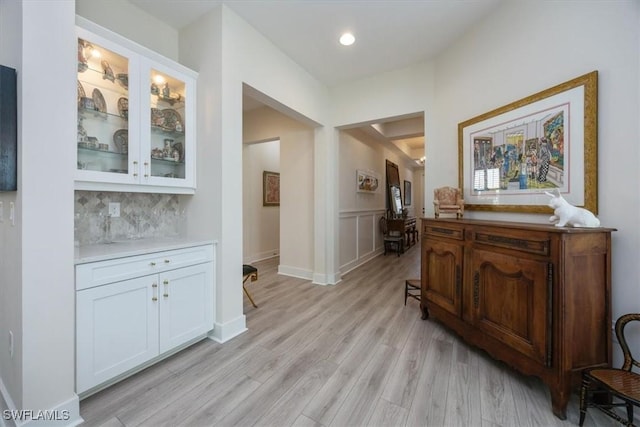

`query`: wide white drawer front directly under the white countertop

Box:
[76,245,213,290]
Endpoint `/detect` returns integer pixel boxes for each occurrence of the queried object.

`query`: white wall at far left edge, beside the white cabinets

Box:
[0,0,79,425]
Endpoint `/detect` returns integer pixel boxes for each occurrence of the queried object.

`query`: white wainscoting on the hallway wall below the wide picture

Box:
[339,209,384,274]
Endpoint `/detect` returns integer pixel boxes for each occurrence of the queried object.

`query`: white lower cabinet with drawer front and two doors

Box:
[76,246,214,393]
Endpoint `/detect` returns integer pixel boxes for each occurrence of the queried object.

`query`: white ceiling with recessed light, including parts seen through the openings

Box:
[129,0,504,167]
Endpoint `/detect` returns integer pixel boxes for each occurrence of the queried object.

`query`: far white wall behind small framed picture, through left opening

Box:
[242,139,280,264]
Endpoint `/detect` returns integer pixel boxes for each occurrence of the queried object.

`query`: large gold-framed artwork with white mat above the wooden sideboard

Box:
[458,71,598,217]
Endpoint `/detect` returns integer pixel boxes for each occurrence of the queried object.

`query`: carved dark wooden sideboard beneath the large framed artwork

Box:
[420,218,615,419]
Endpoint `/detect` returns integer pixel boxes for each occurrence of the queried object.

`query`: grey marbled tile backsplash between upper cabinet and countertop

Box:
[74,191,186,245]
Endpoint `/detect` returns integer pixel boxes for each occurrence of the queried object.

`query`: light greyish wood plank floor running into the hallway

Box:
[80,246,615,427]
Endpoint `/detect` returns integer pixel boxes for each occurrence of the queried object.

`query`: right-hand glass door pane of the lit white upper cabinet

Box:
[145,67,190,180]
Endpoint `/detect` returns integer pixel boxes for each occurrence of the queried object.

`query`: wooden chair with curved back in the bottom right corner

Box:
[580,313,640,426]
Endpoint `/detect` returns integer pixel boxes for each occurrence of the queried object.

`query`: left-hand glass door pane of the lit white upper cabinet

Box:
[77,37,131,181]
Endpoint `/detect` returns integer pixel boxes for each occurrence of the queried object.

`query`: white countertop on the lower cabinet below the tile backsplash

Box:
[74,237,214,264]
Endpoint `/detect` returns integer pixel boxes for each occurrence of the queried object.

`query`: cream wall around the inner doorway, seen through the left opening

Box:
[243,108,315,279]
